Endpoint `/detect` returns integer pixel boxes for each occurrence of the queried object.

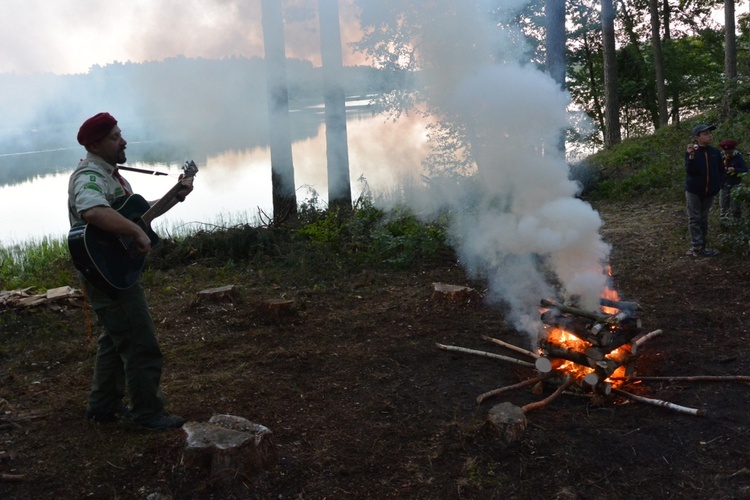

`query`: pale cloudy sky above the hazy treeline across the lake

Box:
[0,0,363,75]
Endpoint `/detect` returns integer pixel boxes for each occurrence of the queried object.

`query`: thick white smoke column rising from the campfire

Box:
[390,0,610,336]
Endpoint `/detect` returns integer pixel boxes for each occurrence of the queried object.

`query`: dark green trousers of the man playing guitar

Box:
[85,283,165,421]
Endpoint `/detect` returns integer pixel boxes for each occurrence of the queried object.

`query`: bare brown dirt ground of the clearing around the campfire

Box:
[0,197,750,499]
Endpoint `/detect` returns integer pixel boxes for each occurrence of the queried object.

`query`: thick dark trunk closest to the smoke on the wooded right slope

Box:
[602,0,622,146]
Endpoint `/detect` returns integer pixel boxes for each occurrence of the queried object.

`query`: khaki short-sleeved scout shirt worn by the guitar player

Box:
[68,152,133,226]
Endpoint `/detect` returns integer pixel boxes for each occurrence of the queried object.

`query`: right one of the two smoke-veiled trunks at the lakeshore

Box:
[318,0,352,210]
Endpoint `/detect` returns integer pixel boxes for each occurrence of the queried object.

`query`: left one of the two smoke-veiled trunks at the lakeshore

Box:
[262,0,297,224]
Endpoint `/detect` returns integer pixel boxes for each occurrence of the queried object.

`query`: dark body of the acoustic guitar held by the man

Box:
[68,194,159,293]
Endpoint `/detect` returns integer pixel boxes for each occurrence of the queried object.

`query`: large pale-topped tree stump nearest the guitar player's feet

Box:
[182,415,277,480]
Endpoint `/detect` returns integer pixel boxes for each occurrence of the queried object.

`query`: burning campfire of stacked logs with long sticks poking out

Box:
[428,284,724,416]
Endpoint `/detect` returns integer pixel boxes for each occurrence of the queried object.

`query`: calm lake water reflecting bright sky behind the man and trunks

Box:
[0,115,427,247]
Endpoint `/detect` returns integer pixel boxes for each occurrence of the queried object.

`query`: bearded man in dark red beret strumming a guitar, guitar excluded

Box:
[68,113,193,429]
